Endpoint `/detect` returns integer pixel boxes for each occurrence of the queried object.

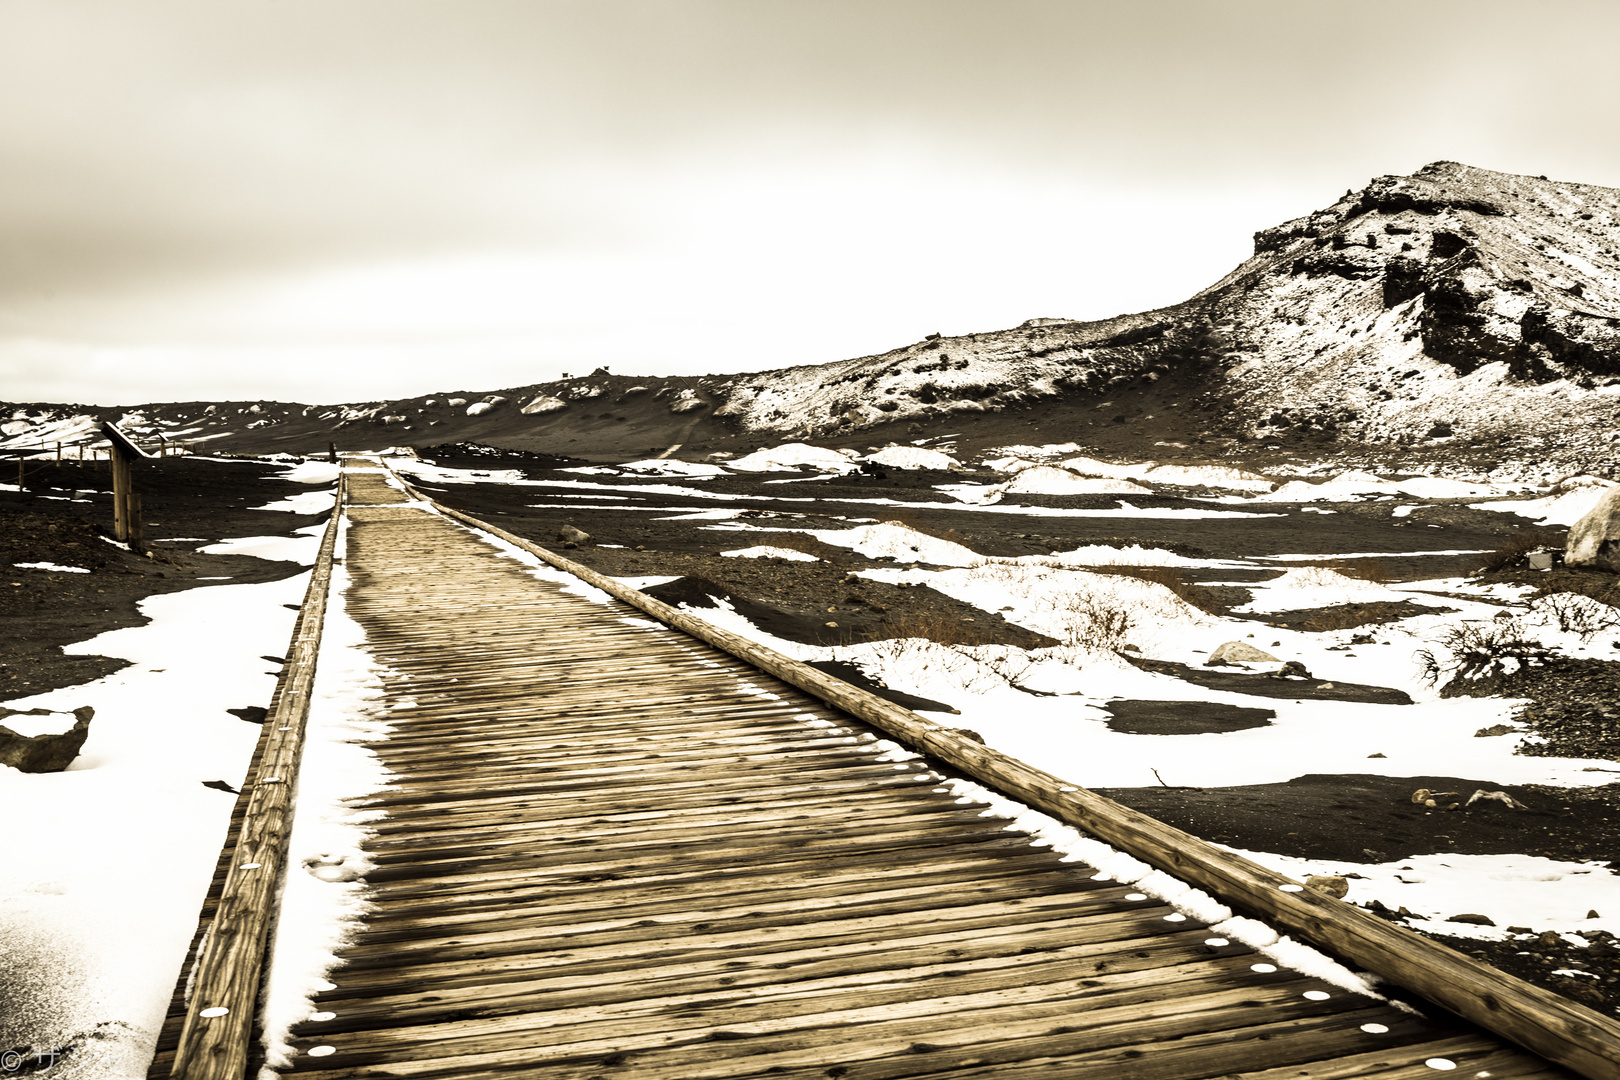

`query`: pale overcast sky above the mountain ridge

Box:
[0,0,1620,405]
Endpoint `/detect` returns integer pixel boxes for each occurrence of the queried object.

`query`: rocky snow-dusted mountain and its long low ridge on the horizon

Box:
[0,162,1620,471]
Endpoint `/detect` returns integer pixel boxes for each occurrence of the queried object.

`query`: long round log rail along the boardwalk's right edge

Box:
[399,478,1620,1080]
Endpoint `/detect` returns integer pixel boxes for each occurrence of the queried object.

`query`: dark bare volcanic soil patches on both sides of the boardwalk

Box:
[0,443,1620,1006]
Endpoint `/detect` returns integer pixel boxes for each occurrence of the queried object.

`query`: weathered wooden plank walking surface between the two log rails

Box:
[167,474,1567,1080]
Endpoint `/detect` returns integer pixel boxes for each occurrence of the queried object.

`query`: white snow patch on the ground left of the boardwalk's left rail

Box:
[0,569,319,1080]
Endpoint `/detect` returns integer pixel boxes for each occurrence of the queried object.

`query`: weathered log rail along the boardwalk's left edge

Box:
[168,476,345,1080]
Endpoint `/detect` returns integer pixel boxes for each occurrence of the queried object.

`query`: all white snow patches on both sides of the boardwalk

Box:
[0,444,1620,1080]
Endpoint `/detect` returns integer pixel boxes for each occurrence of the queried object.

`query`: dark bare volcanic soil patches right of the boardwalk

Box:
[405,453,1620,1009]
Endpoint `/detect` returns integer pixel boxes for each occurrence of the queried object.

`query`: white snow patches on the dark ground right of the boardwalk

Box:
[609,445,1620,936]
